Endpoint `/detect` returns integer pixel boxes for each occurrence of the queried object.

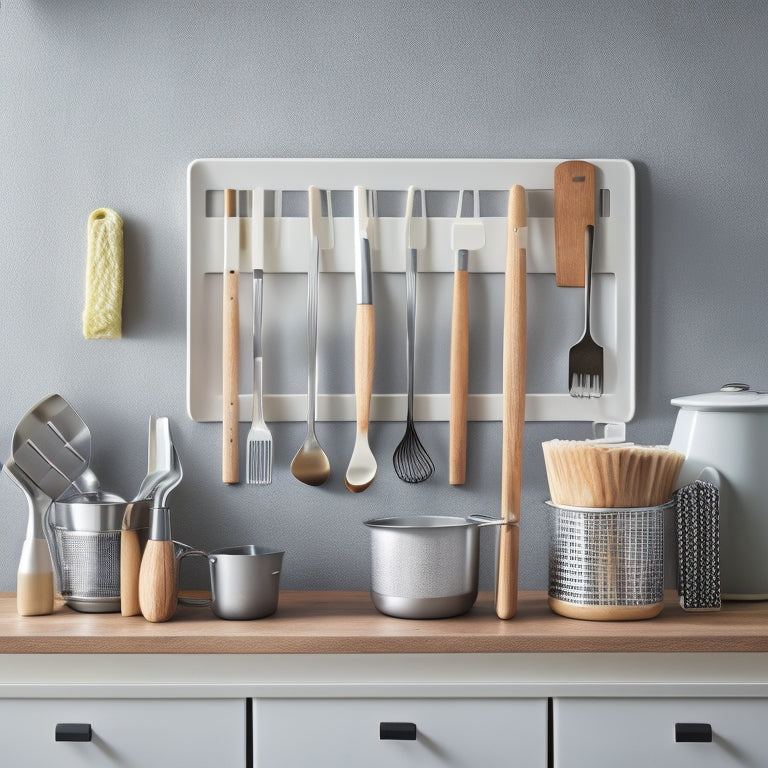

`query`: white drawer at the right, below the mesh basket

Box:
[553,699,768,768]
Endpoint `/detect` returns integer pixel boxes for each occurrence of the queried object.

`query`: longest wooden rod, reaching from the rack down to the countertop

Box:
[496,184,527,619]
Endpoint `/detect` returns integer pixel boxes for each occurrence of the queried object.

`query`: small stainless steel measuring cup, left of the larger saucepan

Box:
[178,544,285,621]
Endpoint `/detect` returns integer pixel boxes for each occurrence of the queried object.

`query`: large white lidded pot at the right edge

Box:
[670,384,768,600]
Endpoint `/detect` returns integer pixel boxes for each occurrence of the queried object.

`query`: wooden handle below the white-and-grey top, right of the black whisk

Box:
[448,269,469,485]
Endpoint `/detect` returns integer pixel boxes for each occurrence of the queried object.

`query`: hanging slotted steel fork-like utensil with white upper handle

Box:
[246,189,272,485]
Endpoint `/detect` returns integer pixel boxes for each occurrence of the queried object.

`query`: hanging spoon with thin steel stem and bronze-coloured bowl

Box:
[291,187,333,485]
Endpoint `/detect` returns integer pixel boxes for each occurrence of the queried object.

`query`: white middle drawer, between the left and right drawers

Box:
[253,699,547,768]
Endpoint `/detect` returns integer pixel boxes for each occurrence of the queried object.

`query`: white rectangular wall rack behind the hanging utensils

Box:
[187,158,635,425]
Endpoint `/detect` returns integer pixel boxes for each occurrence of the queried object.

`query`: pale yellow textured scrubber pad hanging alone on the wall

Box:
[83,208,123,339]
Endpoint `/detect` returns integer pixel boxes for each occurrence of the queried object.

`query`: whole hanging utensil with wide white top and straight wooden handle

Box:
[448,189,485,485]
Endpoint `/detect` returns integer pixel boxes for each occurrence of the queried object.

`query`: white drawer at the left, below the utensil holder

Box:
[0,699,246,768]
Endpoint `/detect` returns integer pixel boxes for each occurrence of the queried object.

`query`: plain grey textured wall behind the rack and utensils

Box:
[0,0,768,589]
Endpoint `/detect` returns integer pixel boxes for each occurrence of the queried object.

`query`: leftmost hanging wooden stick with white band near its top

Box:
[221,189,240,484]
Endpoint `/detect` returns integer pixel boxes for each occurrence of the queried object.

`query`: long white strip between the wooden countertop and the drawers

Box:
[0,653,768,699]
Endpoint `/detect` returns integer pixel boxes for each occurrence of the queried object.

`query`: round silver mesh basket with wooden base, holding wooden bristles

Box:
[547,502,672,620]
